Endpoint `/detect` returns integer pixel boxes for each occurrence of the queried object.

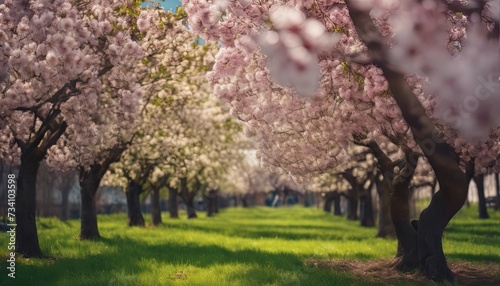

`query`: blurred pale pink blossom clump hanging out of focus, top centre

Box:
[258,6,339,96]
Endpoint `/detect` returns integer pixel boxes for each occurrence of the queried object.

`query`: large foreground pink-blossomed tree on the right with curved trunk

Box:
[183,0,500,280]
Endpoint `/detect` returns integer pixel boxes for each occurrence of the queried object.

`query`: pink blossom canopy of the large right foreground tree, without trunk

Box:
[183,0,500,179]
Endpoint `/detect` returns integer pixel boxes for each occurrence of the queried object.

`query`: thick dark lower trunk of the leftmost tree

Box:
[16,152,42,257]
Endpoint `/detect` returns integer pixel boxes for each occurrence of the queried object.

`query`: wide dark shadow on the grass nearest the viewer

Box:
[5,237,378,285]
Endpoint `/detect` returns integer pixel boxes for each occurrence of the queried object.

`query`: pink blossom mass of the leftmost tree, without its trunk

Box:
[0,0,143,166]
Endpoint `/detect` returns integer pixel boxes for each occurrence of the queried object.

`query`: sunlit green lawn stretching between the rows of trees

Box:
[0,207,500,285]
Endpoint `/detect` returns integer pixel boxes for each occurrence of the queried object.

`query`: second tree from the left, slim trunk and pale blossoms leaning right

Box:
[73,6,213,239]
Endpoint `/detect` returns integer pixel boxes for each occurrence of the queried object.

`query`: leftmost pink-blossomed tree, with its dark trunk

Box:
[0,0,147,256]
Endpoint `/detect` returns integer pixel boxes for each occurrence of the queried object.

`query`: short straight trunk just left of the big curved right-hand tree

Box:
[375,178,396,237]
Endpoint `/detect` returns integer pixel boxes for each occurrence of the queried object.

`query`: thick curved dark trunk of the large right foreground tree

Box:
[346,0,468,281]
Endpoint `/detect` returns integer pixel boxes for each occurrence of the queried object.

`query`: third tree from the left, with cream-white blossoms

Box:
[106,35,246,225]
